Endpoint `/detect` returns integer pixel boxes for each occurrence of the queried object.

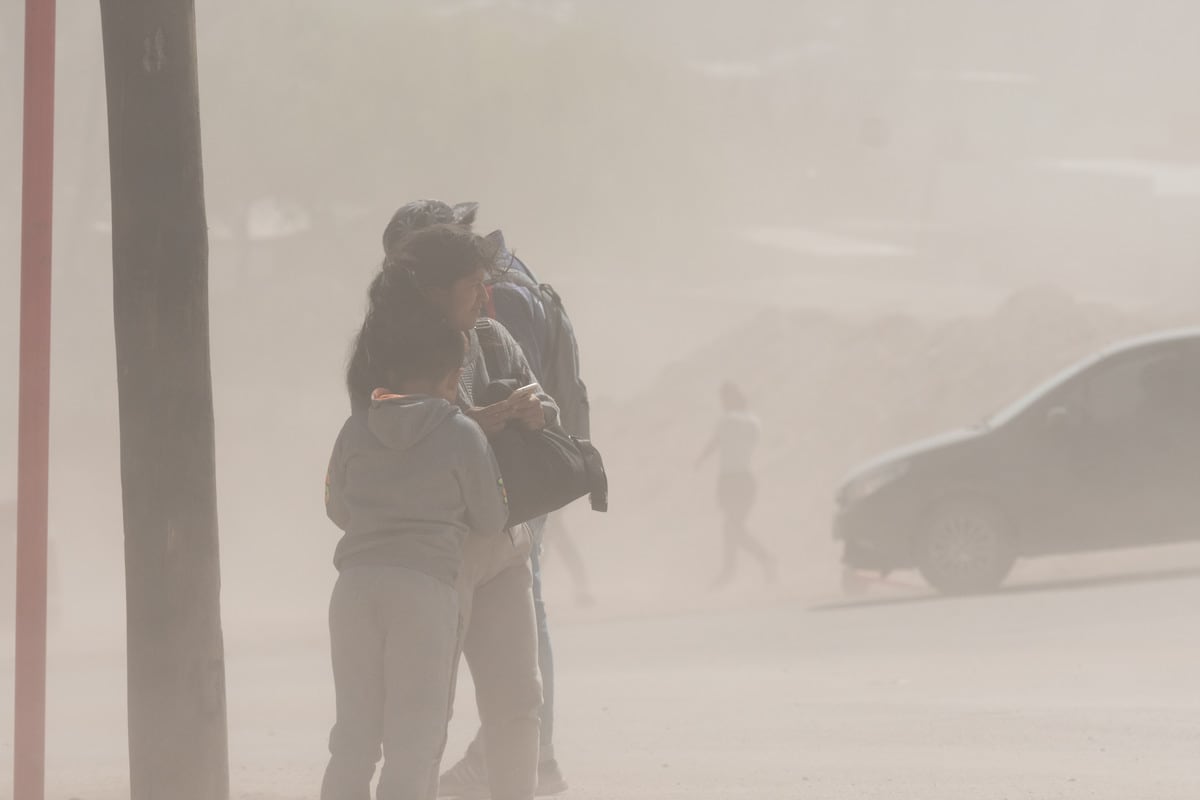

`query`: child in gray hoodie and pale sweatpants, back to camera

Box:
[322,317,508,800]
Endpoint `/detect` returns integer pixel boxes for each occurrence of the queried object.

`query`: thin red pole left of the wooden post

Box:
[13,0,55,800]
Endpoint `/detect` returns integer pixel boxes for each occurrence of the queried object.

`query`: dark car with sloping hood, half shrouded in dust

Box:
[835,329,1200,593]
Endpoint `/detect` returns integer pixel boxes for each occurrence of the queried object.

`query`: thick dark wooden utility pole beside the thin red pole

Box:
[101,0,229,800]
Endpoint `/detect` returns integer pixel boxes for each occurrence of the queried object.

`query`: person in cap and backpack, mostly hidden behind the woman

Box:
[384,200,590,799]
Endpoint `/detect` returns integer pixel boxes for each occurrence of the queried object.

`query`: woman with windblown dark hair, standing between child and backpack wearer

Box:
[347,221,558,800]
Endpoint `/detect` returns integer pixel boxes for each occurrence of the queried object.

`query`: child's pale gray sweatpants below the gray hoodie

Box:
[320,566,458,800]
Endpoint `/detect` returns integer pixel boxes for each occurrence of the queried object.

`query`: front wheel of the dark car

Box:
[916,499,1016,595]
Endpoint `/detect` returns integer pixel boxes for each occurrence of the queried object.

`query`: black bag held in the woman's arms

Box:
[480,380,608,527]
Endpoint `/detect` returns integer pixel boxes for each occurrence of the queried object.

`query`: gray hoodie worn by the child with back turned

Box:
[325,396,509,584]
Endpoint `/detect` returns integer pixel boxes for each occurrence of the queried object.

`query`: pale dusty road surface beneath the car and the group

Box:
[0,569,1200,800]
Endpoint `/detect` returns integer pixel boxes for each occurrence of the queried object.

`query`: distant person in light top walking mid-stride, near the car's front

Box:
[696,381,775,587]
